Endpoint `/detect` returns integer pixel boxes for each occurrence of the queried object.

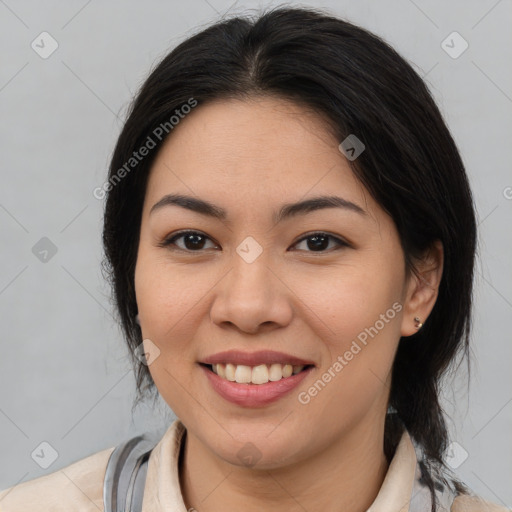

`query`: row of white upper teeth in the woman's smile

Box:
[212,363,304,384]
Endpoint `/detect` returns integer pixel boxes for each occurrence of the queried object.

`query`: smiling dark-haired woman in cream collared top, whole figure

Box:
[0,8,507,512]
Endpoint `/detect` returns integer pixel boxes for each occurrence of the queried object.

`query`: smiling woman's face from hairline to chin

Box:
[135,98,424,467]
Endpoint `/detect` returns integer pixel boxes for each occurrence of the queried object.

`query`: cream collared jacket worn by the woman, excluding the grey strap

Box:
[0,419,509,512]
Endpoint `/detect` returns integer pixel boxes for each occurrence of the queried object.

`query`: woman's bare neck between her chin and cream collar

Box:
[179,412,389,512]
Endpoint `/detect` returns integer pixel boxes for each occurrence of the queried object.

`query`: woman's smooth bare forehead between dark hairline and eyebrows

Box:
[146,97,369,215]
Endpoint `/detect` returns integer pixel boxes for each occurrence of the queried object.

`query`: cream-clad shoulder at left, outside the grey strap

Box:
[0,447,115,512]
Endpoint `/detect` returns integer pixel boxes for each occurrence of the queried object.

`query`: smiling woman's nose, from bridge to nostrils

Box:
[210,248,293,334]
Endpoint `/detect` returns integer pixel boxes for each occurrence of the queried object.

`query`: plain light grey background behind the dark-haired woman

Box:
[0,0,512,507]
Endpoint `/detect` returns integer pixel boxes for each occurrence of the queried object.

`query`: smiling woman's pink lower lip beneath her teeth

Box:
[199,365,314,407]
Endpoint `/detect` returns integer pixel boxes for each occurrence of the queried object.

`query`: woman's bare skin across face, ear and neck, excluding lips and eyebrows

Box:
[135,97,442,512]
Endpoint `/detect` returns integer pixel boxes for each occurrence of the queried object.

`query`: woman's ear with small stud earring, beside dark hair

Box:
[401,240,444,336]
